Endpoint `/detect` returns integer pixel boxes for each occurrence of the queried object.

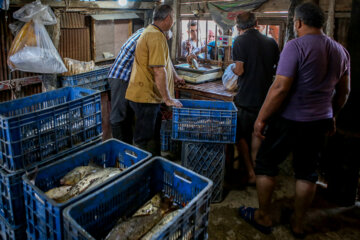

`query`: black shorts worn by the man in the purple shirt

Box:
[255,117,332,183]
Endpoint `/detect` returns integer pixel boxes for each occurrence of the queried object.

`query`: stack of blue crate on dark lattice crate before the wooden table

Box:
[172,100,237,202]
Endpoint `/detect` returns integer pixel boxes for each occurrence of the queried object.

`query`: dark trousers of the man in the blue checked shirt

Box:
[109,78,134,144]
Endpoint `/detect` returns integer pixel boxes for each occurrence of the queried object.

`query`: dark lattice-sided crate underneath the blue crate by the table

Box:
[181,142,225,202]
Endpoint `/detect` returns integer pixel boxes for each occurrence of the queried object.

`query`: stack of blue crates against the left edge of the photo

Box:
[0,88,102,239]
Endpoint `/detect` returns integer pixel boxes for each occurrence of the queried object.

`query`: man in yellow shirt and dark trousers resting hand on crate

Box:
[125,5,182,154]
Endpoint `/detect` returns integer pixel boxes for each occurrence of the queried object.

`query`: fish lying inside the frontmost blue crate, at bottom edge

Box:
[105,193,181,240]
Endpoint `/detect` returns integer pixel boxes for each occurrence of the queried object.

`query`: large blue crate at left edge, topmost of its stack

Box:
[0,87,102,171]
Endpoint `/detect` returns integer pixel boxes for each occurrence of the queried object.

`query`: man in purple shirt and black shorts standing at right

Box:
[239,3,350,237]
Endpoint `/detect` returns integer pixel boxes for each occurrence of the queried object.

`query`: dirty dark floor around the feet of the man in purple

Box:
[208,176,360,240]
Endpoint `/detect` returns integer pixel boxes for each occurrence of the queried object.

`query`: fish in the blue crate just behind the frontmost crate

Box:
[45,166,122,203]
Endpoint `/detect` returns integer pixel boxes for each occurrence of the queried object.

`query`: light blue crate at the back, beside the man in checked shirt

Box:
[60,66,110,91]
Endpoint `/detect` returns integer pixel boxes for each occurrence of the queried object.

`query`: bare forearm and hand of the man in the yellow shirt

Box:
[153,67,182,107]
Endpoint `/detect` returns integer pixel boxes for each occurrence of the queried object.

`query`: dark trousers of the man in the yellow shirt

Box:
[129,101,161,155]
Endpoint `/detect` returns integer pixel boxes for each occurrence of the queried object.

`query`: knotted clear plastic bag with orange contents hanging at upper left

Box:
[7,1,67,74]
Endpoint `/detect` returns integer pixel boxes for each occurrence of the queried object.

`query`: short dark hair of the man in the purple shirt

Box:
[295,3,325,28]
